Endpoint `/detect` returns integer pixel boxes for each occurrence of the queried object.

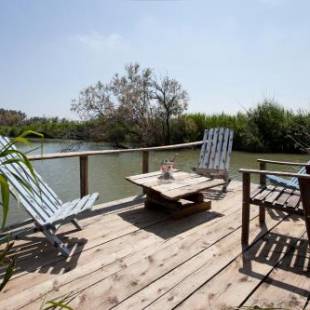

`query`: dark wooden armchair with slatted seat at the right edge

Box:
[239,165,310,246]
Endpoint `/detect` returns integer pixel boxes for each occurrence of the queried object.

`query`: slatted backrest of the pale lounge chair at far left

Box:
[0,136,62,225]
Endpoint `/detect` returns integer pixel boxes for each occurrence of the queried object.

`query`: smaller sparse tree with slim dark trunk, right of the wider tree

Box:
[153,76,189,144]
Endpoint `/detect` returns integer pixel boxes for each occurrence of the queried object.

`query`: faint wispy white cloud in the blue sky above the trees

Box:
[75,32,123,51]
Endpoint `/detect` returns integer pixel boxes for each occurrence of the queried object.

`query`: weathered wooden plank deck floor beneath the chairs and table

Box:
[0,182,310,310]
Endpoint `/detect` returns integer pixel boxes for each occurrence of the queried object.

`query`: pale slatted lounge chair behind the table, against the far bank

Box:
[193,128,234,191]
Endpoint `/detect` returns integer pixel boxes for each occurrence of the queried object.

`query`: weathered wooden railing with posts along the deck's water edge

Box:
[28,141,203,197]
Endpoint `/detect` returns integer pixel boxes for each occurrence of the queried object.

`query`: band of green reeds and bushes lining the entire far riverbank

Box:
[0,100,310,153]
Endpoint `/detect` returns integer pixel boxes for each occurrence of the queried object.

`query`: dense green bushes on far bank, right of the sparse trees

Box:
[184,99,310,153]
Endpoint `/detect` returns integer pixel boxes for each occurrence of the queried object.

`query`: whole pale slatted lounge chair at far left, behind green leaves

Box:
[0,136,98,256]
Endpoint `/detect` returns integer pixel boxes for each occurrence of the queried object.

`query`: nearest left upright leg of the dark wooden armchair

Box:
[241,172,251,246]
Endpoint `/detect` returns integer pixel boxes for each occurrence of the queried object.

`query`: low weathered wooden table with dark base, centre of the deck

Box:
[126,170,225,217]
